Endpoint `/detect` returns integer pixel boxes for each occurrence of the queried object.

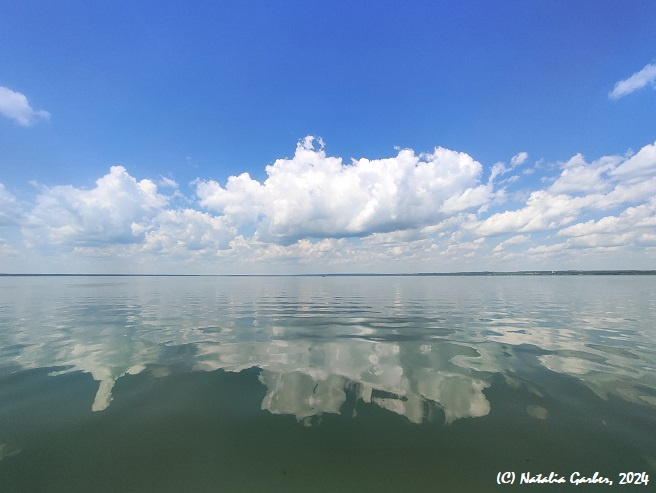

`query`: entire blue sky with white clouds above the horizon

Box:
[0,0,656,274]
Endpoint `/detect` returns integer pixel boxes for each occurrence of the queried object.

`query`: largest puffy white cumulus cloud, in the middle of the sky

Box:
[196,137,491,243]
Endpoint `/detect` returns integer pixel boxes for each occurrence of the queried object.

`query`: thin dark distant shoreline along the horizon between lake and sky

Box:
[0,269,656,277]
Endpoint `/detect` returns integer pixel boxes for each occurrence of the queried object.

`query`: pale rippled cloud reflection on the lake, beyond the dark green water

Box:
[0,272,656,423]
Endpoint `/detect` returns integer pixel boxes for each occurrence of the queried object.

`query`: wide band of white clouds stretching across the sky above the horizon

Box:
[0,137,656,273]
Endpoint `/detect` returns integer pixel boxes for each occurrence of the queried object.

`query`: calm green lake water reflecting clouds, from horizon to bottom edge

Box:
[0,276,656,492]
